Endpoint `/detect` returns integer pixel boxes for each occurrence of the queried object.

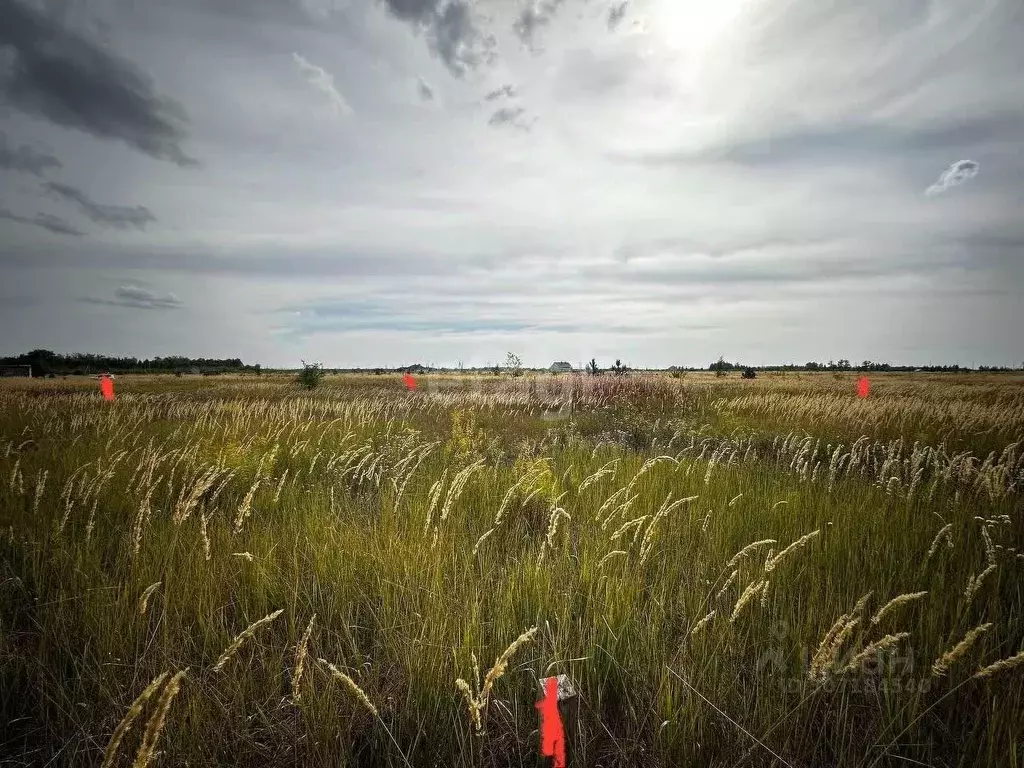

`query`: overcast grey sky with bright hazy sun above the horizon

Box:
[0,0,1024,368]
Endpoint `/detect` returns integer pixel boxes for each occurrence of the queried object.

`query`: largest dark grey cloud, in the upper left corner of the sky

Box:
[0,0,196,166]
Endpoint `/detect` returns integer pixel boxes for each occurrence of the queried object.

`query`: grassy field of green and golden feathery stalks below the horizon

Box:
[0,374,1024,768]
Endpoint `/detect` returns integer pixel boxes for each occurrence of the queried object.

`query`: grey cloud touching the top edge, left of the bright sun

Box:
[379,0,498,78]
